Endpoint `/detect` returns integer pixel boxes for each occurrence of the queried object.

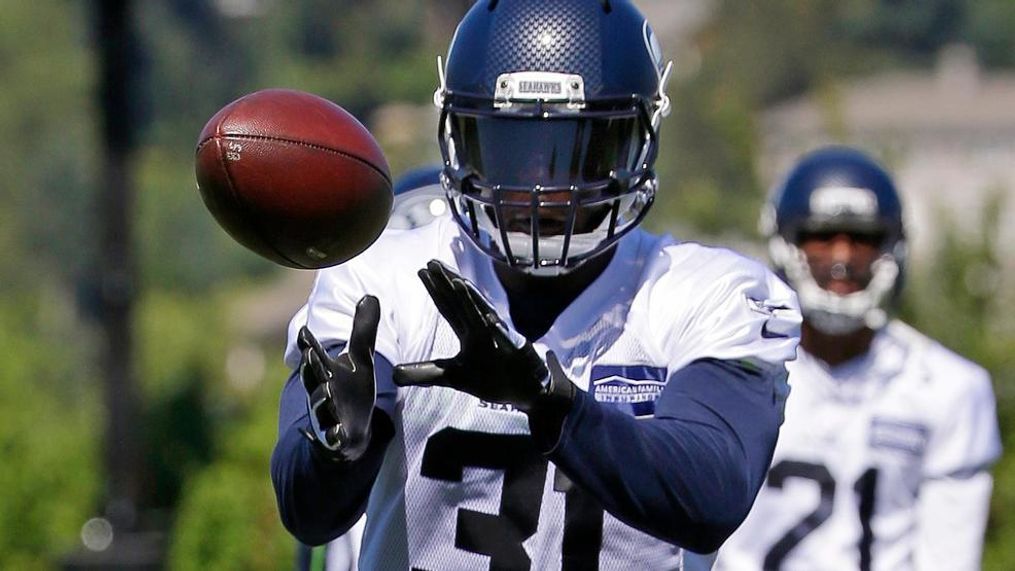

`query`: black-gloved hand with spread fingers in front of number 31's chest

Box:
[394,261,550,411]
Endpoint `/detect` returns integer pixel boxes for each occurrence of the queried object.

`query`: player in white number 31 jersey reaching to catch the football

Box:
[271,0,801,570]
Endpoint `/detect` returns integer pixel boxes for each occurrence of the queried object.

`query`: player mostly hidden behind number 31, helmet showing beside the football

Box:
[293,165,451,571]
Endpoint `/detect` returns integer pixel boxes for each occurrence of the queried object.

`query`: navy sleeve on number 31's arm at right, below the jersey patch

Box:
[530,359,782,553]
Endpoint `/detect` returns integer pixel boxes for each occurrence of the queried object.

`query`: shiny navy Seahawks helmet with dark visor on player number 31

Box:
[434,0,670,275]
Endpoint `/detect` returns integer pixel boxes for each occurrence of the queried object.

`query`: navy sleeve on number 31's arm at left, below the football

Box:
[271,346,397,546]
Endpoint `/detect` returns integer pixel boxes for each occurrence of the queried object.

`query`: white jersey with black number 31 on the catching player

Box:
[286,218,800,570]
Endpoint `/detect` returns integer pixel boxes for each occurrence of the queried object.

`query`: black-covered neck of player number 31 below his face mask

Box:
[494,247,616,341]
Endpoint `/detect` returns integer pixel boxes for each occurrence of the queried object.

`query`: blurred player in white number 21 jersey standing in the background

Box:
[717,147,1001,571]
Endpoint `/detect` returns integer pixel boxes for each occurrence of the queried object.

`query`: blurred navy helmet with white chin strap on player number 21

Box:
[761,146,906,335]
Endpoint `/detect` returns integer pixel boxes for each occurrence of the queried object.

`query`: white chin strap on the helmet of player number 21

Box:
[768,235,899,335]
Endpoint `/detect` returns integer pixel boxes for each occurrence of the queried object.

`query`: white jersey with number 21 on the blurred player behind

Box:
[716,322,1001,571]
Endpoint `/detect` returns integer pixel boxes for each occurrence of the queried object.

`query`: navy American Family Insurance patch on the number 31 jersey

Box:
[589,365,666,417]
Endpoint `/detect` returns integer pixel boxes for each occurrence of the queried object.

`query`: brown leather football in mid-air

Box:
[195,89,392,270]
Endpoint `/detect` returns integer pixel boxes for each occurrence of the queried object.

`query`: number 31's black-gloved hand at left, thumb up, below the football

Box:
[296,295,381,461]
